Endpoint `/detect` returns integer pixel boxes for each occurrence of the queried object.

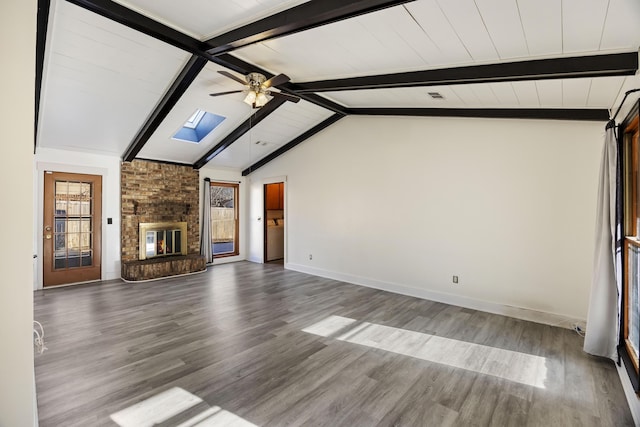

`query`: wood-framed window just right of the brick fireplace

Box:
[211,182,240,258]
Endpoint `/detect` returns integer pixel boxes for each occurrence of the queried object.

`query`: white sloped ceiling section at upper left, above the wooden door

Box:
[38,1,189,155]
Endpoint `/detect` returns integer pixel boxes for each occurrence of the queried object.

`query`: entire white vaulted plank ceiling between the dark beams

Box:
[36,0,640,174]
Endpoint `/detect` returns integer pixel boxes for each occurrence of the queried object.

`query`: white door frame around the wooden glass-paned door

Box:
[33,162,107,290]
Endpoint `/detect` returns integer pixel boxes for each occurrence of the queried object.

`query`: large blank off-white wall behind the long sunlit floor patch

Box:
[248,117,604,326]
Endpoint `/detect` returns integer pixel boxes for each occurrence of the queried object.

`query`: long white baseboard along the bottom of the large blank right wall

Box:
[284,263,586,329]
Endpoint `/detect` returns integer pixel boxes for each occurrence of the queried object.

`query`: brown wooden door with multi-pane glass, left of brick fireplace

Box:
[42,172,102,286]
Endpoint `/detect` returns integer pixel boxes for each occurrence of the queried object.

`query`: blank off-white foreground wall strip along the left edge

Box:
[0,0,37,426]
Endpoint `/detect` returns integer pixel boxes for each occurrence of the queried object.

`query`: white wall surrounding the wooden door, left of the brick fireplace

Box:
[33,149,121,289]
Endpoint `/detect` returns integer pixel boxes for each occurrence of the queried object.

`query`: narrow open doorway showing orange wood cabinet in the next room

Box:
[264,182,285,262]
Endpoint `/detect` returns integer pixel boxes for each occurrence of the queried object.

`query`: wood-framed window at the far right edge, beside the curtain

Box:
[619,107,640,391]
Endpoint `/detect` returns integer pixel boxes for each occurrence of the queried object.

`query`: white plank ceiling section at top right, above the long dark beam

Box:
[236,0,640,82]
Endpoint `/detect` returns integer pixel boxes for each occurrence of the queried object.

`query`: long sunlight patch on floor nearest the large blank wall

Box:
[302,316,547,388]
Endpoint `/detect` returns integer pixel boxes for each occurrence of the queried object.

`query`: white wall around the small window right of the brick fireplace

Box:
[200,167,249,265]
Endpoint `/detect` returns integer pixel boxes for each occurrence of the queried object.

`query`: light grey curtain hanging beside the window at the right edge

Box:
[584,121,622,360]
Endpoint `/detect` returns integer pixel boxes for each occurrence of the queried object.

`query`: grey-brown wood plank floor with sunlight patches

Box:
[35,262,633,427]
